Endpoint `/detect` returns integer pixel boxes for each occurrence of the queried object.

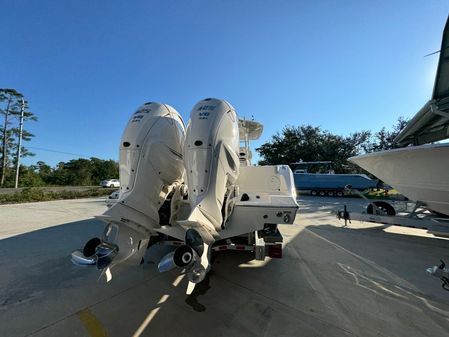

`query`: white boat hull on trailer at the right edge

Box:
[349,144,449,215]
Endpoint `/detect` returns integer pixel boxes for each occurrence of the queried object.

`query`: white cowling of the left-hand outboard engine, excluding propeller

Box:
[111,103,185,229]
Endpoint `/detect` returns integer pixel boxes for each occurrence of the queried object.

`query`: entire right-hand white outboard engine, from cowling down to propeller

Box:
[158,98,239,294]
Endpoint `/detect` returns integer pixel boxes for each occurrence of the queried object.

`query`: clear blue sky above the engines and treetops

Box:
[0,0,449,166]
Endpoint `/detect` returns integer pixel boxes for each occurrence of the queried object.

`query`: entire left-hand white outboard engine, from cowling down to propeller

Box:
[72,103,185,269]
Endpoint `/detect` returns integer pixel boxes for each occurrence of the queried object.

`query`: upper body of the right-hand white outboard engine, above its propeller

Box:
[179,98,239,244]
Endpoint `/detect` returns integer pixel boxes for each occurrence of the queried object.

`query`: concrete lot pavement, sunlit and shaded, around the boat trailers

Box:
[0,197,449,337]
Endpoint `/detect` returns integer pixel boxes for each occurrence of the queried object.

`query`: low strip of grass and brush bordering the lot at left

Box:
[0,187,112,204]
